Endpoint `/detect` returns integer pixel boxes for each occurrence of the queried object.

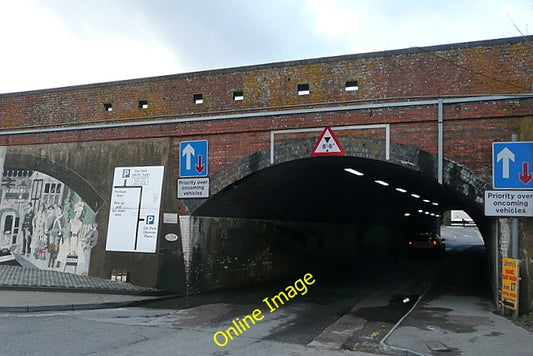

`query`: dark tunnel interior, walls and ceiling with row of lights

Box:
[188,156,492,292]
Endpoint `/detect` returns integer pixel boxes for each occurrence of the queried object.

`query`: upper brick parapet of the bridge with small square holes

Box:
[0,37,533,129]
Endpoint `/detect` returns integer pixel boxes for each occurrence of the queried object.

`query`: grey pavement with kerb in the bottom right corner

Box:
[380,292,533,356]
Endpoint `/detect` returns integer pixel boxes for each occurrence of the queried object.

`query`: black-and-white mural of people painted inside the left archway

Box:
[0,168,98,275]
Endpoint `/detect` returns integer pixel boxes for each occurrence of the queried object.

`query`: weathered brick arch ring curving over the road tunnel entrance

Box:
[182,137,489,213]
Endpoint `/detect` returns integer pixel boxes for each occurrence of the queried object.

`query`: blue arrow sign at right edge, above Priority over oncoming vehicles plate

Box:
[492,142,533,189]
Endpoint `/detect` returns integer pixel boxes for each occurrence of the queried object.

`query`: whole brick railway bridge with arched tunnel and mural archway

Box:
[0,37,533,311]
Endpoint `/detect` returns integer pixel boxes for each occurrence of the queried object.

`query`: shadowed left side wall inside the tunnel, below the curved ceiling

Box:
[187,216,398,294]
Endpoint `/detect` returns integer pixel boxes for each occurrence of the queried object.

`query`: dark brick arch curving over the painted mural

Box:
[5,153,104,212]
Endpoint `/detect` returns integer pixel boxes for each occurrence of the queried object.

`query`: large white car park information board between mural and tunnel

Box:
[106,166,164,253]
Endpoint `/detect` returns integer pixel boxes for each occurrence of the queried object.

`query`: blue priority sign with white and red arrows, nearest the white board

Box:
[180,140,209,178]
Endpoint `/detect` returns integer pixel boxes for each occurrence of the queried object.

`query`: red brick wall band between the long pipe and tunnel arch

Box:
[0,99,533,189]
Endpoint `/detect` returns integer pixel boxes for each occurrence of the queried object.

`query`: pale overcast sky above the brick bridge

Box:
[0,0,533,93]
